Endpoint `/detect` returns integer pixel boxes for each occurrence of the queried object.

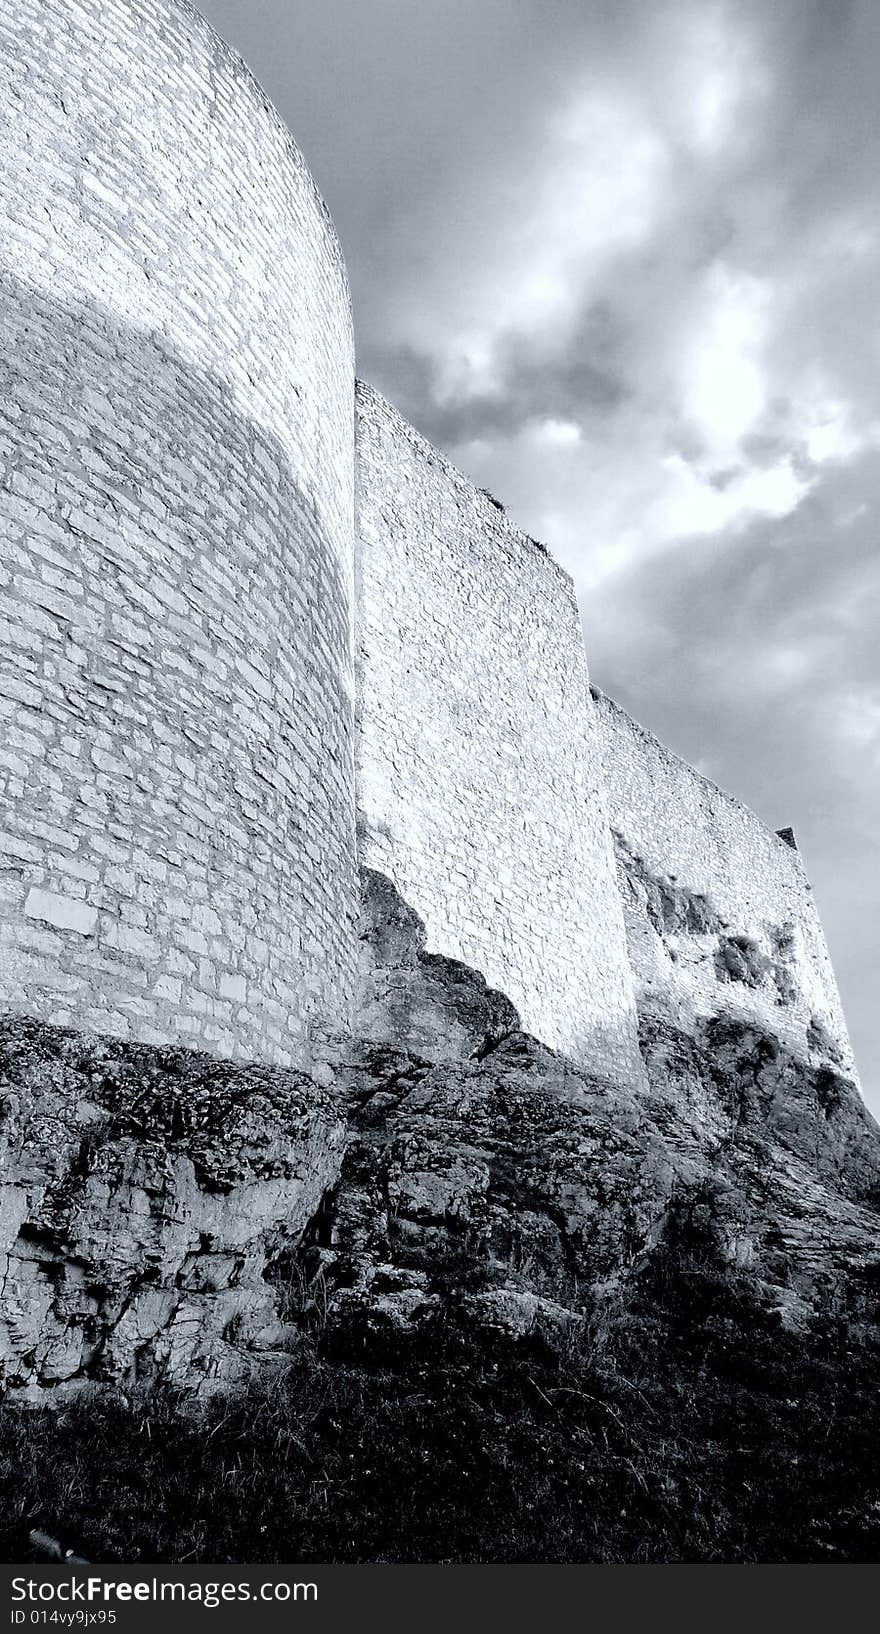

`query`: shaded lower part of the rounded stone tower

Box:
[0,276,356,1062]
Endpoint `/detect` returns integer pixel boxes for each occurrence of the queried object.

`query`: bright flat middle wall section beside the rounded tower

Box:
[358,387,640,1075]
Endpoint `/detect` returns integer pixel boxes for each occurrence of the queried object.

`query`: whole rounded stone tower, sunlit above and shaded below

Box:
[0,0,356,1062]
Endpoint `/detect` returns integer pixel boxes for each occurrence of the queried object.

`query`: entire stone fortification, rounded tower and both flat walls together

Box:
[0,0,851,1098]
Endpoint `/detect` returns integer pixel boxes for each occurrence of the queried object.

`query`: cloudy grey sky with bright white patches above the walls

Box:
[201,0,880,1111]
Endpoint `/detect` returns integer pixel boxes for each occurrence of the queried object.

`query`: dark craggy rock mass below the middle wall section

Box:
[304,1033,674,1330]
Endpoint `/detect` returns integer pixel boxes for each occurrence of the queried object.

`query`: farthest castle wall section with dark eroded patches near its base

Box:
[594,693,854,1074]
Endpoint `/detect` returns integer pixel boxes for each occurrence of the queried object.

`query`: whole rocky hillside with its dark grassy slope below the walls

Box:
[0,879,880,1562]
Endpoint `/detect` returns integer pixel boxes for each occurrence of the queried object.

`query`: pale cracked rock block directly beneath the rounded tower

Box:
[0,1020,344,1399]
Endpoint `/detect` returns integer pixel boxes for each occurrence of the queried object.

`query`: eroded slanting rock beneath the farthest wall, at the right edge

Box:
[642,1016,880,1327]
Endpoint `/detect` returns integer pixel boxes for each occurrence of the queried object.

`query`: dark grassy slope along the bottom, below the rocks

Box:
[0,1243,880,1564]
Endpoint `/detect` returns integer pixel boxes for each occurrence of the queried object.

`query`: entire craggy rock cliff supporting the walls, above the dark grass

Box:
[0,874,880,1557]
